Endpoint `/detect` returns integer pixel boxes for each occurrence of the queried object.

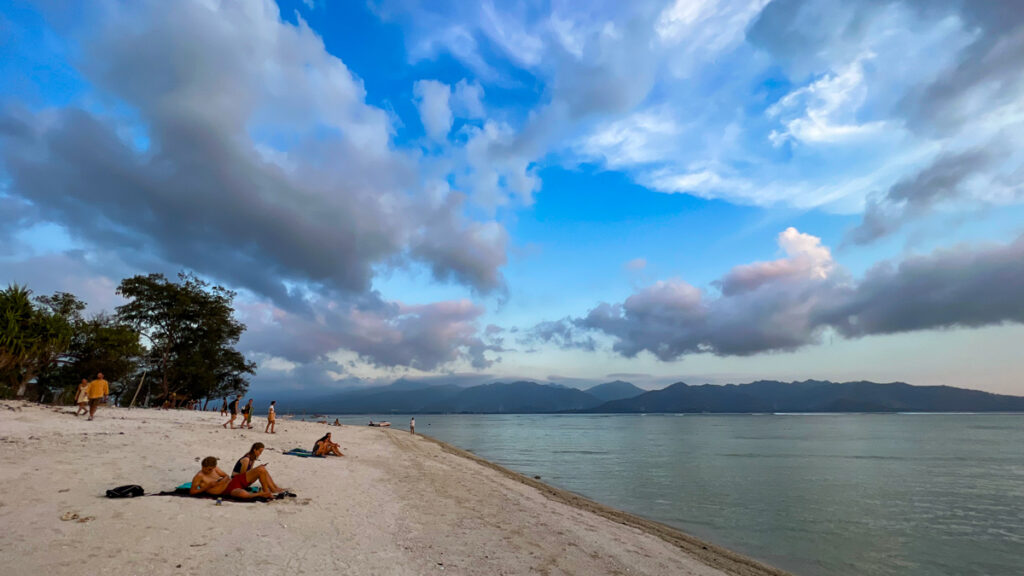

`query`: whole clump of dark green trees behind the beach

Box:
[0,274,255,405]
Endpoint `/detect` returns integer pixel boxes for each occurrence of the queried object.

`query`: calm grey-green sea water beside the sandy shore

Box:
[315,414,1024,576]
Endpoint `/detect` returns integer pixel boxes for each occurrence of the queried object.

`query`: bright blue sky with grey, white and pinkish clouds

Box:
[0,0,1024,395]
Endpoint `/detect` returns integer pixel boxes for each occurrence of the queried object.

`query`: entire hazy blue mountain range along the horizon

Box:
[291,380,1024,414]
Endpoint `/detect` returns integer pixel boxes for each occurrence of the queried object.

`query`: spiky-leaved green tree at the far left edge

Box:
[0,284,76,397]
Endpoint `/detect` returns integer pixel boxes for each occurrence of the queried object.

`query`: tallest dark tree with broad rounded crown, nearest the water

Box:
[118,274,256,400]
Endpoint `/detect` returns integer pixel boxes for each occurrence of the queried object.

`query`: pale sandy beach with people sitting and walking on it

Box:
[0,402,784,576]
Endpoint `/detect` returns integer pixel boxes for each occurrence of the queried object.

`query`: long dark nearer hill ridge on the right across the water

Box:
[587,380,1024,413]
